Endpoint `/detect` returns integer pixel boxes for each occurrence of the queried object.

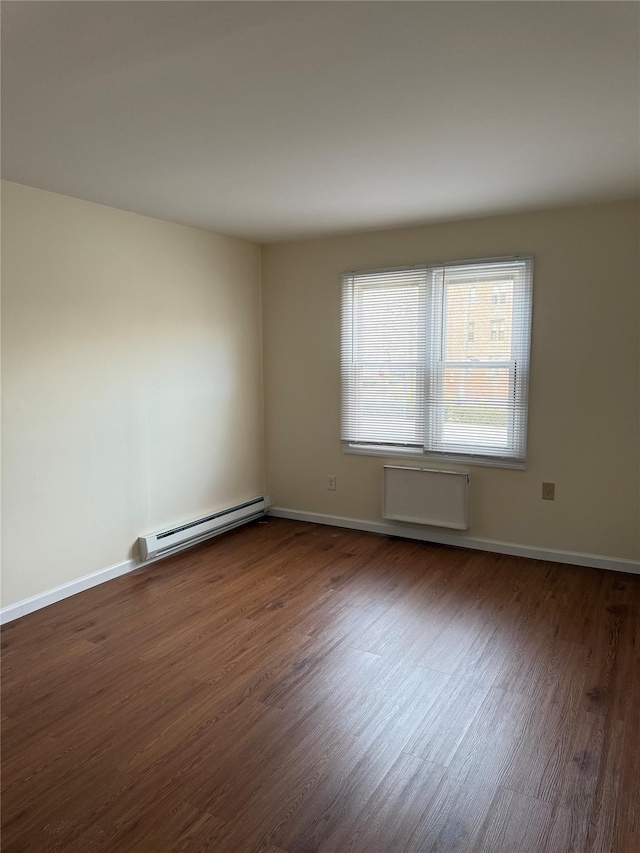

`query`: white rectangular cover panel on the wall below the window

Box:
[382,465,469,530]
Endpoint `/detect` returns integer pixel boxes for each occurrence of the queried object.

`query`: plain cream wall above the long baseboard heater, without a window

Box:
[2,183,264,606]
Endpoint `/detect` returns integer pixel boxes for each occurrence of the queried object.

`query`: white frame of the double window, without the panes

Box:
[341,254,533,469]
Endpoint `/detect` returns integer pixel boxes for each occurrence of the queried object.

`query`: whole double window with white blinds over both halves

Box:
[341,256,533,467]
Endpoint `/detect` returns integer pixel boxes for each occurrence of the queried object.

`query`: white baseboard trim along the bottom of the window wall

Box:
[269,506,640,575]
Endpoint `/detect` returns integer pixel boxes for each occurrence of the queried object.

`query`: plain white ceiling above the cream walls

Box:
[2,0,640,241]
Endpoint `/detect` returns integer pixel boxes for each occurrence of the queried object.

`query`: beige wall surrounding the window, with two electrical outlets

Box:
[262,202,640,559]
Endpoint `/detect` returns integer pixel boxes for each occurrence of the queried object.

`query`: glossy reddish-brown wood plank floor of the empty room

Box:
[2,519,640,853]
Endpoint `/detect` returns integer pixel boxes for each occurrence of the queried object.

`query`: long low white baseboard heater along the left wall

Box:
[138,495,271,561]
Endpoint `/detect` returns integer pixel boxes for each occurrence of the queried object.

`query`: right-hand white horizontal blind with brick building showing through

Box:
[425,259,531,461]
